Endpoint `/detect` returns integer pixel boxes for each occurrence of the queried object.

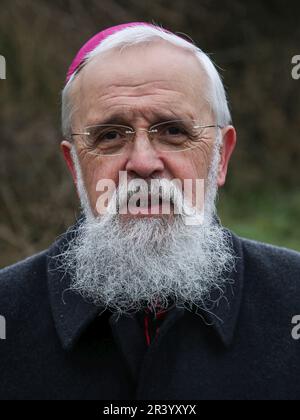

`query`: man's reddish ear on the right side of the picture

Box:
[218,125,236,187]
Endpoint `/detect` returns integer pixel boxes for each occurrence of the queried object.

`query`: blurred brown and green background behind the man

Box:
[0,0,300,267]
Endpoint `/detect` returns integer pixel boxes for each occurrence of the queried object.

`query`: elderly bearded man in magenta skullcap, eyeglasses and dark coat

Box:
[0,22,300,400]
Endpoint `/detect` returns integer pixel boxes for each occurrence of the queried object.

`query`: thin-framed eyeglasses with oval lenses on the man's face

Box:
[71,120,222,156]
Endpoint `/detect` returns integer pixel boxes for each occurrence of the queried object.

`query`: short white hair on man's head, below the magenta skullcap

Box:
[62,25,231,139]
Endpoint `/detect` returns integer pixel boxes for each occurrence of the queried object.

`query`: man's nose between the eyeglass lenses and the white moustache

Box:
[126,131,165,178]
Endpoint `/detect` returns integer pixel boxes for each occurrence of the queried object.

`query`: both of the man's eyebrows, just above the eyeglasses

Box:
[88,111,189,126]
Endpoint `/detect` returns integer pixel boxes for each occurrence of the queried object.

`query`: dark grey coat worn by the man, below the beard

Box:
[0,221,300,400]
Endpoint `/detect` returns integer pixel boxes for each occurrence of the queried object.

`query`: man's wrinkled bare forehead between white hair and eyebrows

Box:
[72,40,209,118]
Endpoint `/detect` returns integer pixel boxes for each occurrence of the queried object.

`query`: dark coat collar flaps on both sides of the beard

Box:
[47,217,244,351]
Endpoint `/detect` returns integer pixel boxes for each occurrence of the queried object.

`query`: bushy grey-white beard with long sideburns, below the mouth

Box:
[60,141,235,315]
